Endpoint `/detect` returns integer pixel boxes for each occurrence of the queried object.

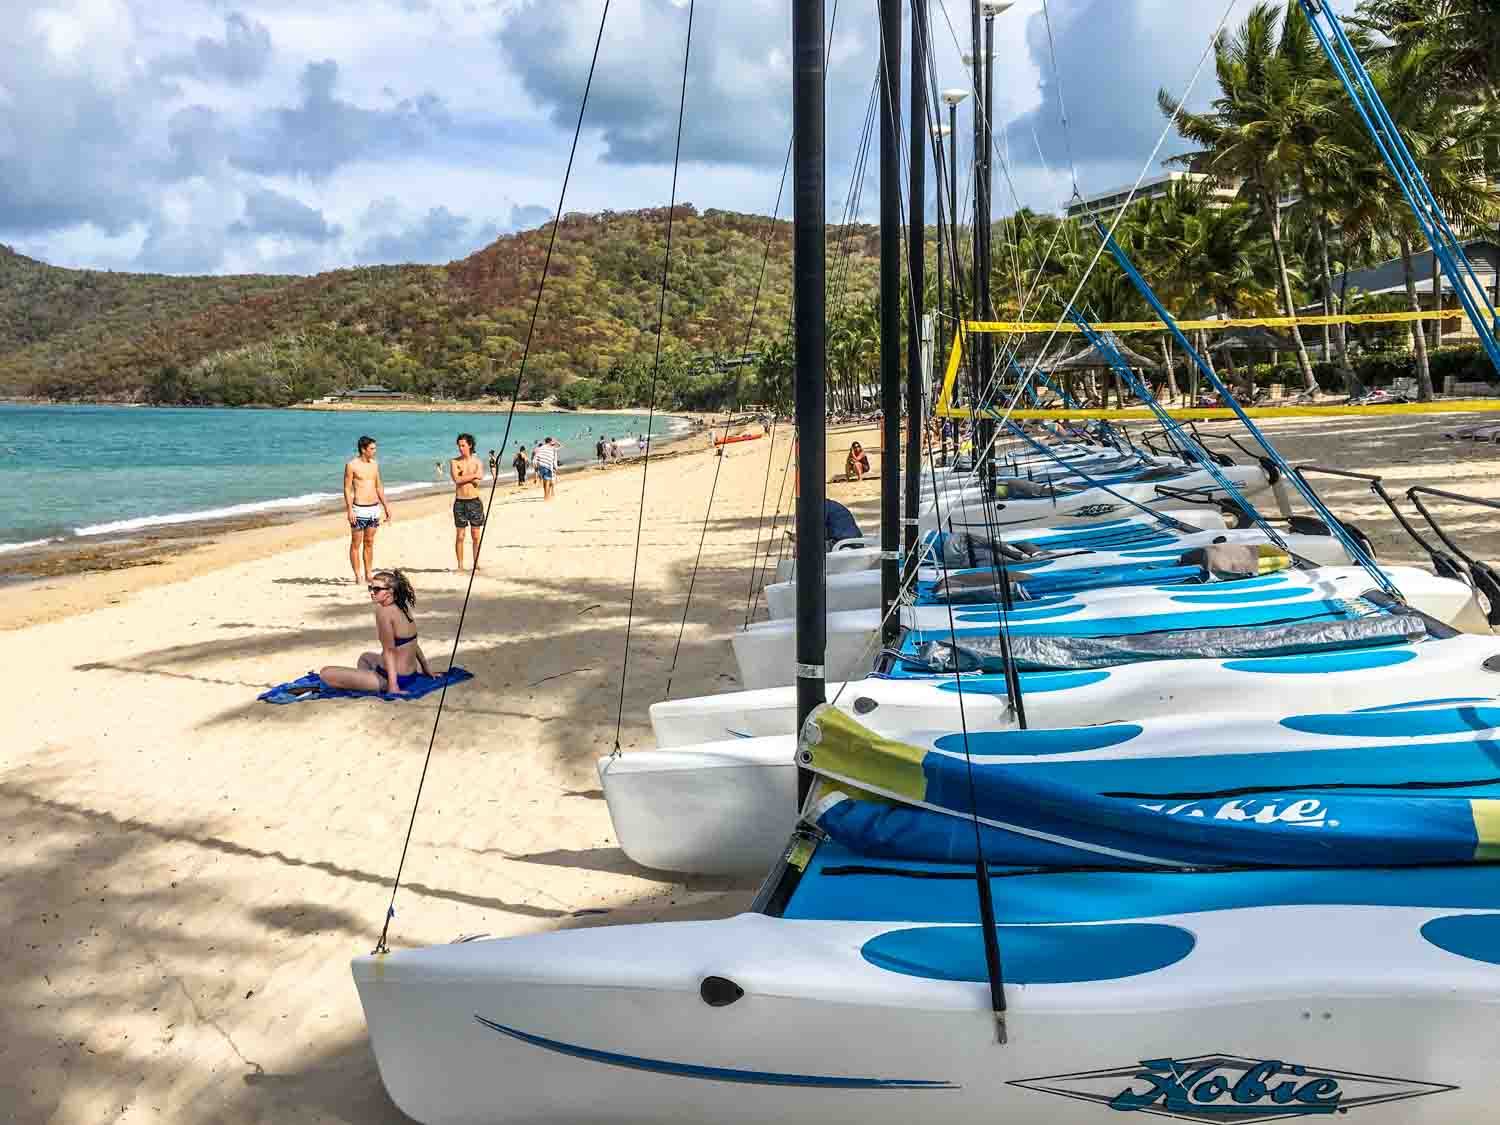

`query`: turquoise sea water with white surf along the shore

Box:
[0,405,678,552]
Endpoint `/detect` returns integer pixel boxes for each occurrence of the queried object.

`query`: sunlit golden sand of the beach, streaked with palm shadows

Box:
[0,414,1500,1125]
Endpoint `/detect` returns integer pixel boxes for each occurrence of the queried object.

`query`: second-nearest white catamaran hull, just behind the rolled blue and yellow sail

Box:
[612,636,1500,875]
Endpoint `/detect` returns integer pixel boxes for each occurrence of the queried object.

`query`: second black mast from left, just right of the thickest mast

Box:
[881,0,902,645]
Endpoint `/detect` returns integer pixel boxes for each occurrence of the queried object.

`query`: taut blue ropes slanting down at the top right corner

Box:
[1301,0,1500,374]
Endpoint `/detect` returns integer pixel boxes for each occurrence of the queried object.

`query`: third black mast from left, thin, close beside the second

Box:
[902,0,927,567]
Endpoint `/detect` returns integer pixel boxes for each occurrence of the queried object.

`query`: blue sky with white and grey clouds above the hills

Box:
[0,0,1356,273]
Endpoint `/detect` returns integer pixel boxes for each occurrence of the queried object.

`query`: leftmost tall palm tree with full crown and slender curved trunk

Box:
[1157,3,1334,390]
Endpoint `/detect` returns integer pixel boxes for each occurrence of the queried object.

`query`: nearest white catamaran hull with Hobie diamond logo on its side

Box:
[353,918,1500,1125]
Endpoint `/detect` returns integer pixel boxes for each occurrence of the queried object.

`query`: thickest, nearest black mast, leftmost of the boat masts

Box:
[792,0,828,807]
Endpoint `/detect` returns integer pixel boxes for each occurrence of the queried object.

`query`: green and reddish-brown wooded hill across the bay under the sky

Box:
[0,204,879,407]
